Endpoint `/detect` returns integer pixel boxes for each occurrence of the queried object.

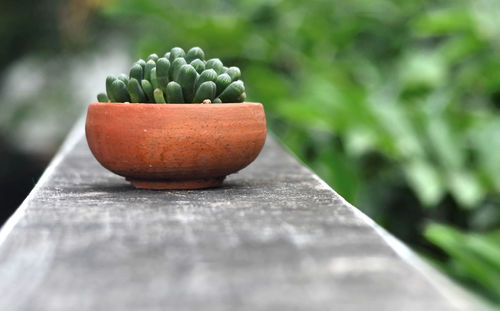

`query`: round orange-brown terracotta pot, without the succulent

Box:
[85,103,266,189]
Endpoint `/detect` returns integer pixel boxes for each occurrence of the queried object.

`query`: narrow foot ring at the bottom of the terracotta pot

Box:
[127,176,226,190]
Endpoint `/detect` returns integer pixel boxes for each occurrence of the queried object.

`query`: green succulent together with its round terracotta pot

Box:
[85,47,266,189]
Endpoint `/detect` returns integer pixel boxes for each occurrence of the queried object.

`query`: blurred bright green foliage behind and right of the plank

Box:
[17,0,494,303]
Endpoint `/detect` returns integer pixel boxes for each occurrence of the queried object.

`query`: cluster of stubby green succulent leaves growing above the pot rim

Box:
[97,47,246,104]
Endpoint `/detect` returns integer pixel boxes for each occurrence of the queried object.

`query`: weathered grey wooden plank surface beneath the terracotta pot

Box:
[0,122,486,311]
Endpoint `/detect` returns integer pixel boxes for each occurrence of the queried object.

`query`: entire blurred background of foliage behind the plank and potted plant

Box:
[0,0,500,305]
